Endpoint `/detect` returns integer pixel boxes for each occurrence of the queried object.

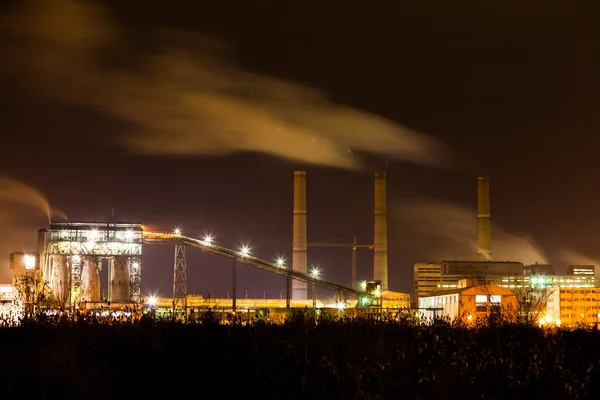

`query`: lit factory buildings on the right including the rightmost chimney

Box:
[413,176,600,326]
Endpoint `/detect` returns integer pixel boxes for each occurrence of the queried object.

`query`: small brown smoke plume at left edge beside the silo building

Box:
[0,175,50,283]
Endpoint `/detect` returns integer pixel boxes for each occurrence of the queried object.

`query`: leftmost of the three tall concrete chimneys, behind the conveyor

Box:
[292,171,308,299]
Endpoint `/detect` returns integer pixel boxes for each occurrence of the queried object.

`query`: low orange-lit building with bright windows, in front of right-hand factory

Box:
[419,280,518,322]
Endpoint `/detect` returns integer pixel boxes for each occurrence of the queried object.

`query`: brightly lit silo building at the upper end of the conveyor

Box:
[38,222,143,304]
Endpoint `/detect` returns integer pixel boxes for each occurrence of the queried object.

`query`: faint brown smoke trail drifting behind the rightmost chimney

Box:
[390,200,546,264]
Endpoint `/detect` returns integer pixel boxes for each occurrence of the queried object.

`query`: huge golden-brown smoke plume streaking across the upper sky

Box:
[0,0,447,168]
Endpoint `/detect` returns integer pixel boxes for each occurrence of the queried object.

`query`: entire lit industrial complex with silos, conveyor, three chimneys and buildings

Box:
[0,171,600,325]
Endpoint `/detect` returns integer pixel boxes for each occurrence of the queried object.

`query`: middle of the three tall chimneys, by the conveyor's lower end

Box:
[373,172,388,290]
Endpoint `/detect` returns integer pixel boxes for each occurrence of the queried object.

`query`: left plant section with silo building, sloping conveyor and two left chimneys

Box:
[2,171,410,316]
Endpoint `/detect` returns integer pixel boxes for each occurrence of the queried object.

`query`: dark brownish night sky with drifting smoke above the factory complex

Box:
[0,0,600,296]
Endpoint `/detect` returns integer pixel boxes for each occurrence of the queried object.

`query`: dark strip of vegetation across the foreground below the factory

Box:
[0,316,600,400]
